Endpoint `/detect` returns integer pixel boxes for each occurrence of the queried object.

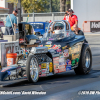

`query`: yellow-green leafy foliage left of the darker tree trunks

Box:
[7,0,48,13]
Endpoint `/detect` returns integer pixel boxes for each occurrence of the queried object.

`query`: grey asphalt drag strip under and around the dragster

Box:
[0,35,100,100]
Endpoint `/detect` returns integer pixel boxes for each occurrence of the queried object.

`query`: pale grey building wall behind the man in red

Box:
[71,0,100,29]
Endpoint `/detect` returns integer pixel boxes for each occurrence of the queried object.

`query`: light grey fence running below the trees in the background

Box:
[0,12,65,22]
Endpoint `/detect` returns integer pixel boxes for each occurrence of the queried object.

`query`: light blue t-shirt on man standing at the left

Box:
[5,14,17,27]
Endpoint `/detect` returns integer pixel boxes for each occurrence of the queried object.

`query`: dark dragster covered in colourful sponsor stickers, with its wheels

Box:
[0,20,92,82]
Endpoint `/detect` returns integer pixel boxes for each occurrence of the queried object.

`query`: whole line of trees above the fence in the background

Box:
[7,0,70,13]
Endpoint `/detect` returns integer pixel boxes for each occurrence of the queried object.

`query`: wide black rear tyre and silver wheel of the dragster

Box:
[74,44,92,74]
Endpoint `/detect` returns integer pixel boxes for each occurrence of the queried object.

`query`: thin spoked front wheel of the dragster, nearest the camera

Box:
[26,55,39,82]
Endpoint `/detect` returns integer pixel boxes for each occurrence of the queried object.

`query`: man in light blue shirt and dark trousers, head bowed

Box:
[5,10,18,35]
